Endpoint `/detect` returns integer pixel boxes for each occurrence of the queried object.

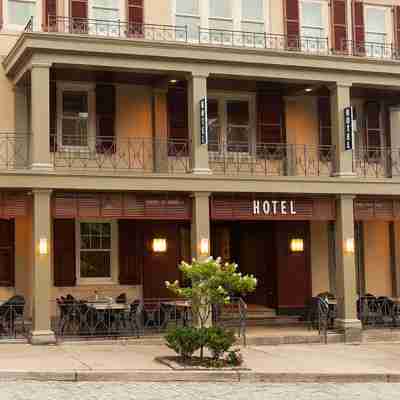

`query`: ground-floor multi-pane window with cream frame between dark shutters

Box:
[77,221,116,281]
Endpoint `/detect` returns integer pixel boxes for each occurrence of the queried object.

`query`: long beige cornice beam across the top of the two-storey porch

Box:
[3,33,400,88]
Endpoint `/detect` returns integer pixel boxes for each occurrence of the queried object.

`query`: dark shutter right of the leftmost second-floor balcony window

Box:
[96,85,115,153]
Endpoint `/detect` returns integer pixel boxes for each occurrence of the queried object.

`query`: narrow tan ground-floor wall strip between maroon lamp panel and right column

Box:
[310,221,329,296]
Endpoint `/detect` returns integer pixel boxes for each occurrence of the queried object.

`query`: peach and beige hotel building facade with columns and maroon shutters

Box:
[0,0,400,343]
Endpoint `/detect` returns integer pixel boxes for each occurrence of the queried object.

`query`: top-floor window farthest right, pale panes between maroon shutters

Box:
[365,6,392,57]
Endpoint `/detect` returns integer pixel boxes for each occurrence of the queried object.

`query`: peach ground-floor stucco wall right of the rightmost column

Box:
[364,221,392,296]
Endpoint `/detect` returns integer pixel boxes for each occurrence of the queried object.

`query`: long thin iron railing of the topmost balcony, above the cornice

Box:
[21,16,400,60]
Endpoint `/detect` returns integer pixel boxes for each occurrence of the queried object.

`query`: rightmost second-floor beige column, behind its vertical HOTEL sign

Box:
[331,82,355,177]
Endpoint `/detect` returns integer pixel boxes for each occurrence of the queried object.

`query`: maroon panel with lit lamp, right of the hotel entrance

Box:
[276,221,311,313]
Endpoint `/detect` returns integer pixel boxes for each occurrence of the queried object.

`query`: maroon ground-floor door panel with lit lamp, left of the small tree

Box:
[143,222,181,299]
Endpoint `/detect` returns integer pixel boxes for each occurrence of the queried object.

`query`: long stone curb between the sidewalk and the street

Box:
[0,370,400,384]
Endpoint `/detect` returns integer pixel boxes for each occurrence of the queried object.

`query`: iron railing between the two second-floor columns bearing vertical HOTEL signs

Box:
[209,142,335,176]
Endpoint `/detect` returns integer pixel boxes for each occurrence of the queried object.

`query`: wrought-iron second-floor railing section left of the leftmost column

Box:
[0,132,30,170]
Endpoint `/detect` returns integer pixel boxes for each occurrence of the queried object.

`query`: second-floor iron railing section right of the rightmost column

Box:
[353,147,400,178]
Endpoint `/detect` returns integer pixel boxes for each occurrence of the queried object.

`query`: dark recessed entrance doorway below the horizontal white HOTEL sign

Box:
[237,222,276,308]
